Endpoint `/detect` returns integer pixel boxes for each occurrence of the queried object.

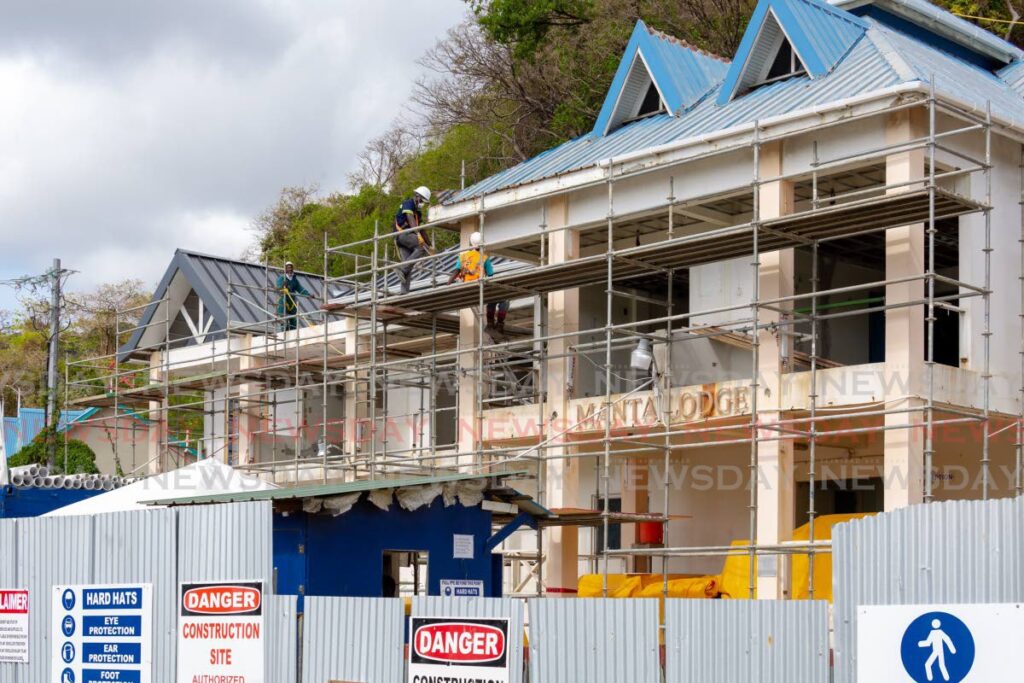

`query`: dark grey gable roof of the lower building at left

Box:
[119,249,324,359]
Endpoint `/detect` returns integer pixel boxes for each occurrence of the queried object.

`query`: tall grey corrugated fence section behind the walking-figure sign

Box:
[833,498,1024,683]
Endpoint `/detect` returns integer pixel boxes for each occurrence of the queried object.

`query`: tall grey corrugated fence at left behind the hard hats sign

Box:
[0,503,274,683]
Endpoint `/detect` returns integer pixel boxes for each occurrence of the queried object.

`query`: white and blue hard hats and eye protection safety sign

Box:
[50,584,153,683]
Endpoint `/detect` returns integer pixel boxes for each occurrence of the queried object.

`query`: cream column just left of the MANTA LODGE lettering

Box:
[542,197,587,595]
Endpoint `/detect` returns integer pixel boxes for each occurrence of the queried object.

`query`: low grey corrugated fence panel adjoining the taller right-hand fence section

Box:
[665,600,828,683]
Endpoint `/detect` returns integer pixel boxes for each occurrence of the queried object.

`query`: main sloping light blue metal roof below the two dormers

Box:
[446,0,1024,204]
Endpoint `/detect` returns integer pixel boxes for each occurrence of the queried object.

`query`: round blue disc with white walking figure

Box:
[900,611,974,683]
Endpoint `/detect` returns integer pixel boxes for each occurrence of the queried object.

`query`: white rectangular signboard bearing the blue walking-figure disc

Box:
[857,604,1024,683]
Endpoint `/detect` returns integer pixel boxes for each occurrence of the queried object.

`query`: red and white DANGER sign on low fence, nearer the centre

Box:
[409,616,510,683]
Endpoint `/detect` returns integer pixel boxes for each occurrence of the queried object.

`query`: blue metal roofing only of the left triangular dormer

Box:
[594,22,729,135]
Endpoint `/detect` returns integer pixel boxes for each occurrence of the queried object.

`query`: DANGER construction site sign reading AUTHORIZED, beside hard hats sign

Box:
[178,581,263,683]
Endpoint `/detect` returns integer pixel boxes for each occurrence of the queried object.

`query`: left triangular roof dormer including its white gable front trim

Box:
[594,22,729,135]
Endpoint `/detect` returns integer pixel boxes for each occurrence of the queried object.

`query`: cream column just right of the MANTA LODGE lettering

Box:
[757,142,795,599]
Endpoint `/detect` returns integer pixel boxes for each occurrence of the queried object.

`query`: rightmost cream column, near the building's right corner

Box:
[883,104,928,510]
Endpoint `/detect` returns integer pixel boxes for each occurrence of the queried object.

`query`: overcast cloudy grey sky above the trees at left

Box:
[0,0,466,309]
